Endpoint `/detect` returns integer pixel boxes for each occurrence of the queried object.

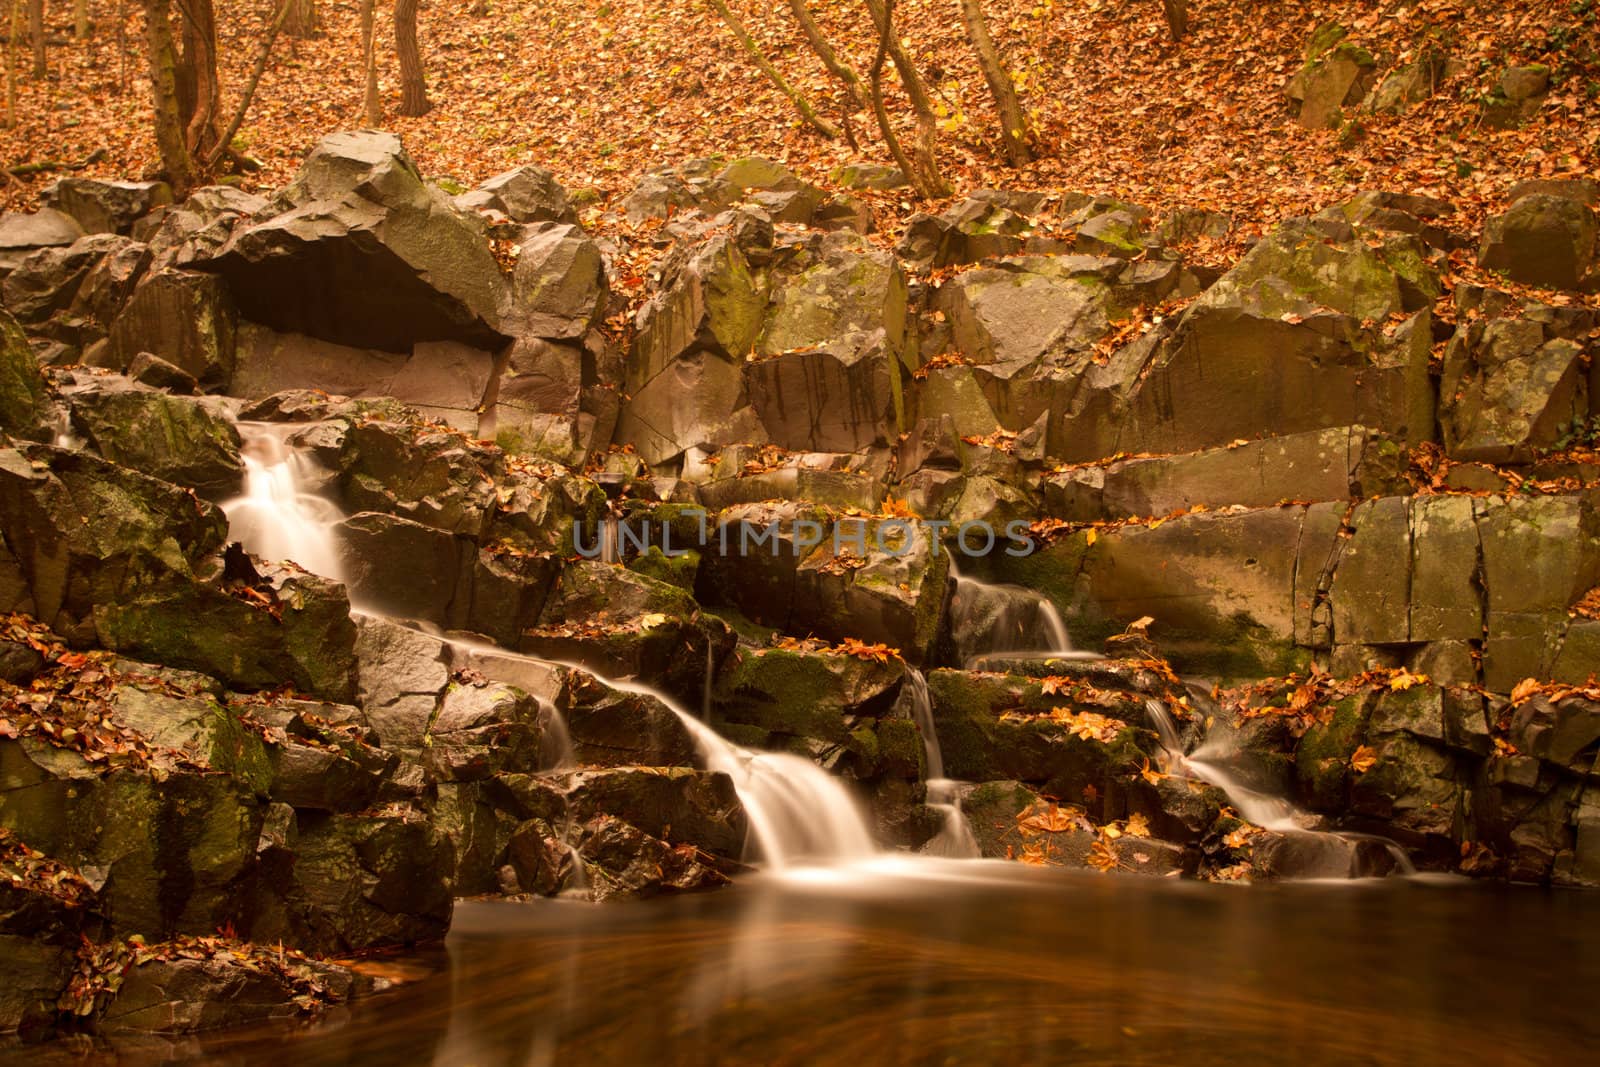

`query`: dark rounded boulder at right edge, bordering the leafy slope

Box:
[1478,194,1597,290]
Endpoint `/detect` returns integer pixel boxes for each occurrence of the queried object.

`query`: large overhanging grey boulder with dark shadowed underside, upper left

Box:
[203,131,504,352]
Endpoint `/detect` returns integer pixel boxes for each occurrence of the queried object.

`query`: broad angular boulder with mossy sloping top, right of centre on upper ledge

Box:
[1034,219,1434,461]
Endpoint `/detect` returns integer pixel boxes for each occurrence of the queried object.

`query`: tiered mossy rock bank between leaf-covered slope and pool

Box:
[0,123,1600,1032]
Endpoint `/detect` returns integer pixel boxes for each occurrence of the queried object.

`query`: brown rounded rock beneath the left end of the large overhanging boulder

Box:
[106,270,238,387]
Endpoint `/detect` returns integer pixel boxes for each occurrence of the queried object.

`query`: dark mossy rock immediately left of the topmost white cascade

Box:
[67,382,245,501]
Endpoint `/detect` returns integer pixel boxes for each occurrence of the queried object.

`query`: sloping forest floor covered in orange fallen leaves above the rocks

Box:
[0,0,1600,244]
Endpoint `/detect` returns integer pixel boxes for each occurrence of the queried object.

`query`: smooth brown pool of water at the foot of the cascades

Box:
[15,862,1600,1067]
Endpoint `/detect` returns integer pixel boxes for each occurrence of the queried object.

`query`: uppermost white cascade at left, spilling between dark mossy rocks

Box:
[222,422,344,581]
